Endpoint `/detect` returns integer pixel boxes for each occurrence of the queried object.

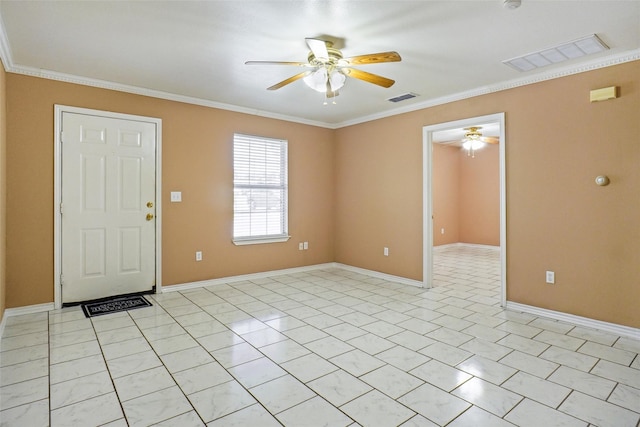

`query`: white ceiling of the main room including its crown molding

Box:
[0,0,640,128]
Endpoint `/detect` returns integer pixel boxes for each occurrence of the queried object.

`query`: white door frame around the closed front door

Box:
[53,104,162,309]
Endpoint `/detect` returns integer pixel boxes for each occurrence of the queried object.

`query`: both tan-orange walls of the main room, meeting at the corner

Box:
[6,61,640,328]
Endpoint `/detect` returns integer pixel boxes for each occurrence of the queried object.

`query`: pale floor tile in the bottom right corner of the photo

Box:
[558,391,640,427]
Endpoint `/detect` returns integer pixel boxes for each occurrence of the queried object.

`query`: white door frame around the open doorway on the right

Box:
[422,113,507,307]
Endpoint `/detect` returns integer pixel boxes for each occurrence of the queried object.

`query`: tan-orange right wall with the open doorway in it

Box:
[335,61,640,328]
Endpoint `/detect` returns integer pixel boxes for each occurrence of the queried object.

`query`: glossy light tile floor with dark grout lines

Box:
[0,246,640,427]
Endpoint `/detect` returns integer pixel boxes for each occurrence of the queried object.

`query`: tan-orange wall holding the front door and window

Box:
[6,73,334,307]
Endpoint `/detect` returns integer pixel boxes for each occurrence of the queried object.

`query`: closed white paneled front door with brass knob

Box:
[61,112,156,303]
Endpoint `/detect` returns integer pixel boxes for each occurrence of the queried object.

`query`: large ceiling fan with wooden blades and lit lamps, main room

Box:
[245,38,401,98]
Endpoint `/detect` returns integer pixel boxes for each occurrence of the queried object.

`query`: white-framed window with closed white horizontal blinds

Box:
[233,134,289,245]
